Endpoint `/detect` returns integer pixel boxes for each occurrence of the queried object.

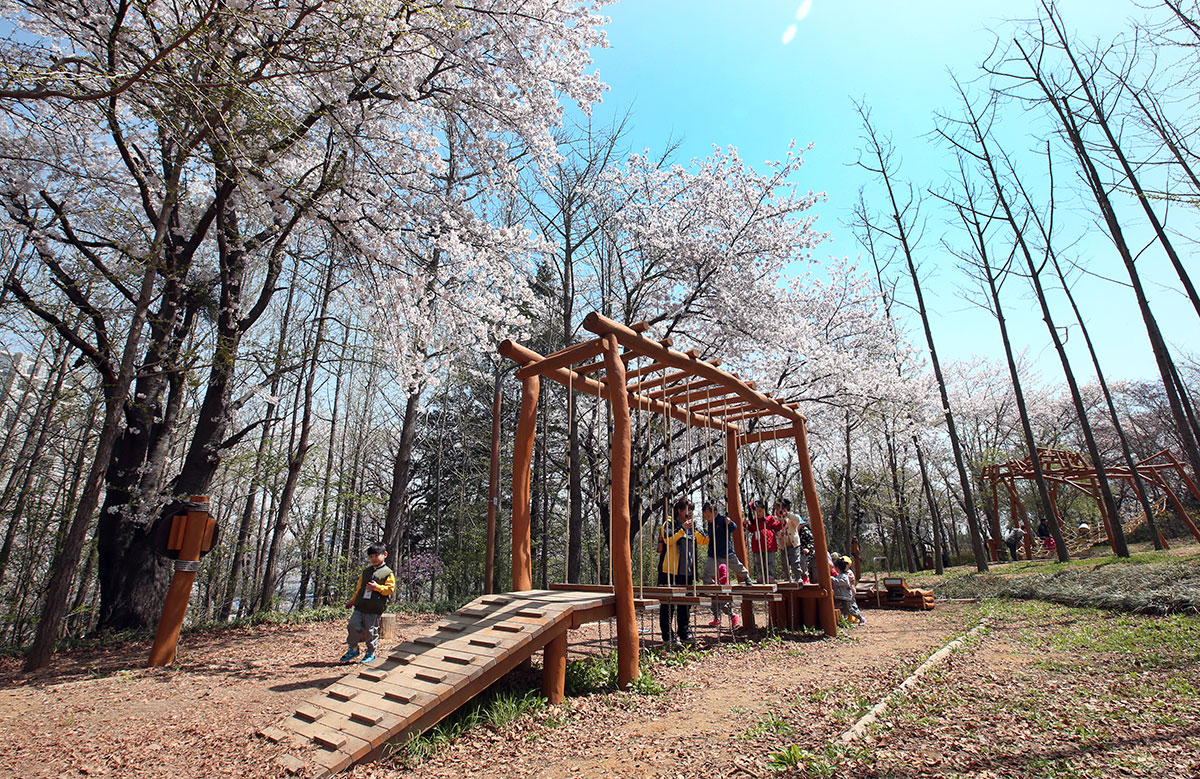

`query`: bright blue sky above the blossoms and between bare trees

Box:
[585,0,1200,383]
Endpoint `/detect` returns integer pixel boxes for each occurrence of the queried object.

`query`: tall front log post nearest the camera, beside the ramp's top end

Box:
[604,334,640,689]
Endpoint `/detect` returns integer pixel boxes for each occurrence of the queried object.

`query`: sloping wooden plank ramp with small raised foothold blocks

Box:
[259,589,616,777]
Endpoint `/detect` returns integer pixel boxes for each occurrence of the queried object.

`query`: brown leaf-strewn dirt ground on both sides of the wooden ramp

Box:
[0,606,973,779]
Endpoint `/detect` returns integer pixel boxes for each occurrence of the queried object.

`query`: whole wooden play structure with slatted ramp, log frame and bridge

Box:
[262,313,838,777]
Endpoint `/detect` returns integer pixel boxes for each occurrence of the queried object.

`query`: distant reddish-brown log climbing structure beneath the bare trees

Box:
[983,447,1200,562]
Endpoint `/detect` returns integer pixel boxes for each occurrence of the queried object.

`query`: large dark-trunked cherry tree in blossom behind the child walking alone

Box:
[0,0,604,666]
